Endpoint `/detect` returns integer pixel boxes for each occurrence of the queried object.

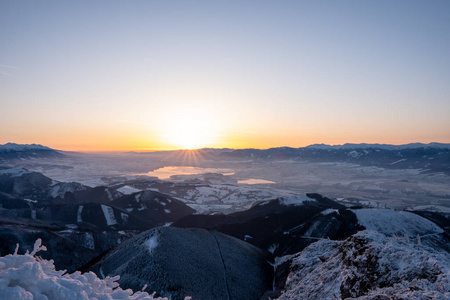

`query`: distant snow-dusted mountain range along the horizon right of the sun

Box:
[215,143,450,174]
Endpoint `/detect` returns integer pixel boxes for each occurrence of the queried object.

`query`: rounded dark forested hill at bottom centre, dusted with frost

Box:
[91,227,273,299]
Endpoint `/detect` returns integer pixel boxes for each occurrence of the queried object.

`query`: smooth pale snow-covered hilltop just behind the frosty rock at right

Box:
[352,208,444,237]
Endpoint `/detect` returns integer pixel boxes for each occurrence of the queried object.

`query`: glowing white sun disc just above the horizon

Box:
[162,109,216,150]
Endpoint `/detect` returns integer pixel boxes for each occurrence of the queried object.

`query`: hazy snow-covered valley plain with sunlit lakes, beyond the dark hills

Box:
[10,152,450,212]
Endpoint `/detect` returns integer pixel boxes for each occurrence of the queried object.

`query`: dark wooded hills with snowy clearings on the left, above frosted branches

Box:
[0,168,194,271]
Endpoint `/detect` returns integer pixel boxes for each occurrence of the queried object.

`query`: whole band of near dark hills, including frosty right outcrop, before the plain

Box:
[0,168,450,299]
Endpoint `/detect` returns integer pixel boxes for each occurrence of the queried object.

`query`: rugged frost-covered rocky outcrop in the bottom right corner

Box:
[279,230,450,299]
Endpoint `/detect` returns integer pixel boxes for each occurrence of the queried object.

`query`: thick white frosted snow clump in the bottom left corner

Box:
[0,240,166,300]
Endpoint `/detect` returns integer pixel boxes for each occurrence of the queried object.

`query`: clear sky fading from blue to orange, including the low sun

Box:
[0,0,450,151]
